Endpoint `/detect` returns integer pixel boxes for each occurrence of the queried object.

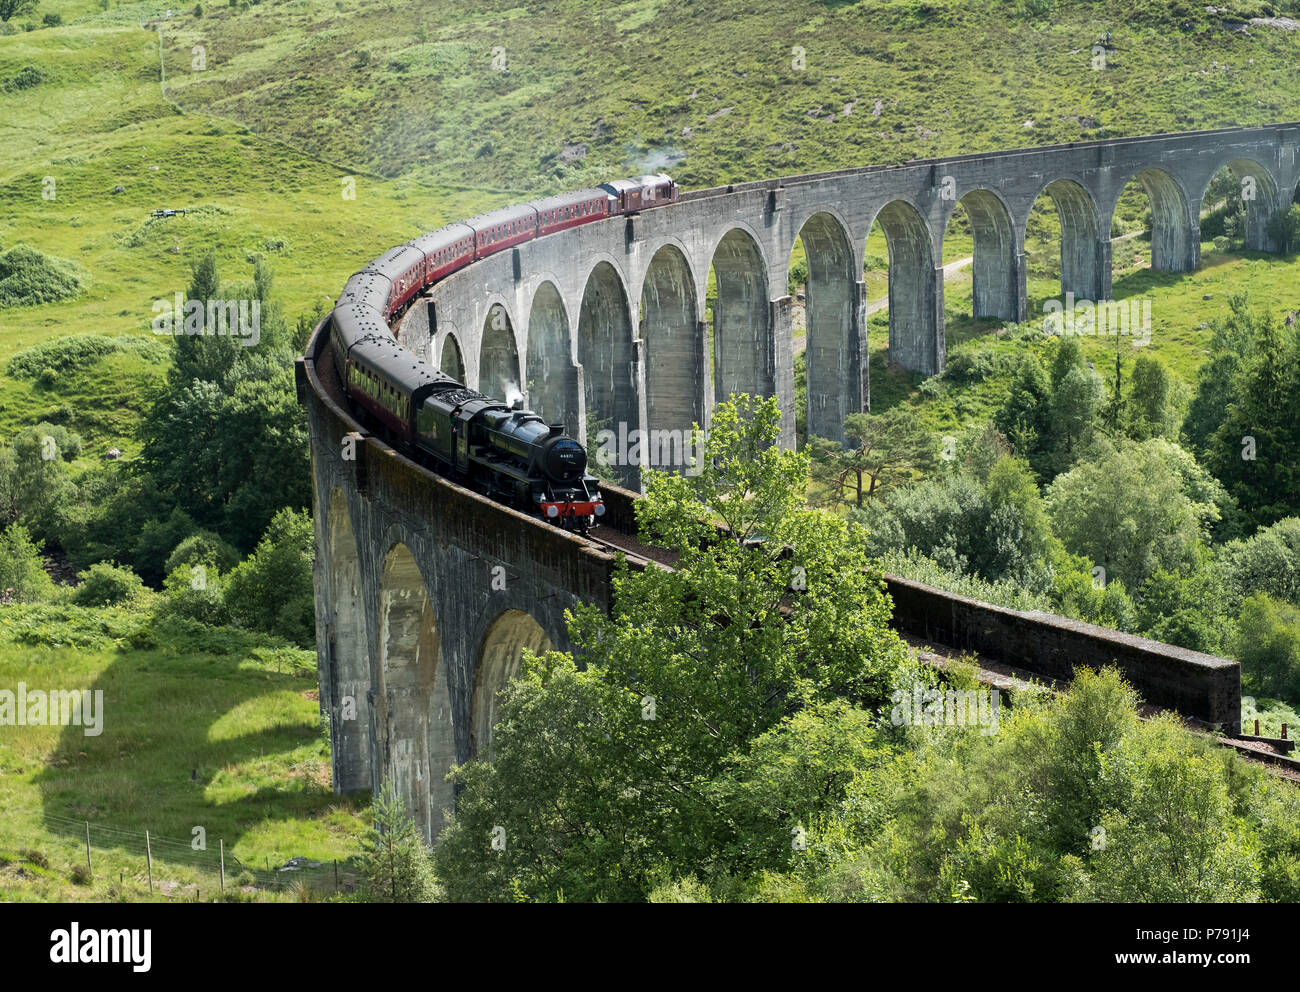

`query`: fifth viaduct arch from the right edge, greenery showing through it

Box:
[876,200,944,376]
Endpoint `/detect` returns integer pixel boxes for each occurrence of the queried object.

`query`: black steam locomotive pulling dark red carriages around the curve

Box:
[329,173,680,533]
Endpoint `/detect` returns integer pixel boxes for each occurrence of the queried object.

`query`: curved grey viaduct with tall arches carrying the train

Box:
[299,124,1300,840]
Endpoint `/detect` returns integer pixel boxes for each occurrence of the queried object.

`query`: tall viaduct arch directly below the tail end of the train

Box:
[640,244,705,468]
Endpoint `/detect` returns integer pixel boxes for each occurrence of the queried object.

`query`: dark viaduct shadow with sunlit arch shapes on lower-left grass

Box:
[35,650,368,857]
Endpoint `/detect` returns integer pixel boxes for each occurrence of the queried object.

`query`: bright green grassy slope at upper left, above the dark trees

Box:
[0,16,503,456]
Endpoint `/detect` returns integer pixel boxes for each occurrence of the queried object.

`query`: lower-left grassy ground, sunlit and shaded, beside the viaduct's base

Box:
[0,608,361,900]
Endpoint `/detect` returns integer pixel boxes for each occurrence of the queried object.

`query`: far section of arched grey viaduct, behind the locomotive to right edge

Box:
[399,124,1300,455]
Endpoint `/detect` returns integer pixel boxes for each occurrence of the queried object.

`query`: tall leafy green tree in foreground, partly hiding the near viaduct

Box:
[437,397,909,901]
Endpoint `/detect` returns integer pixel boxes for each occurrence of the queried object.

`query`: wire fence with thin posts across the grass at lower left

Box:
[44,813,361,894]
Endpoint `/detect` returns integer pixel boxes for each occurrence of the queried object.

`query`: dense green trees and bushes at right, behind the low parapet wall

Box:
[809,294,1300,703]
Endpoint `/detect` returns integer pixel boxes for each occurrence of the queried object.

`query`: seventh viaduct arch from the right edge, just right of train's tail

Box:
[712,228,776,402]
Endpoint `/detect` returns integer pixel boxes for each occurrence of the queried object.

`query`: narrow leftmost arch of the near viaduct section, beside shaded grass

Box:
[325,486,373,792]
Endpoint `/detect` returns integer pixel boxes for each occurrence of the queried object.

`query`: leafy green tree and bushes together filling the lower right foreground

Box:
[436,392,1300,902]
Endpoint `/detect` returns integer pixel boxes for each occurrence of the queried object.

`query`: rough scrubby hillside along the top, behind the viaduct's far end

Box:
[144,0,1300,191]
